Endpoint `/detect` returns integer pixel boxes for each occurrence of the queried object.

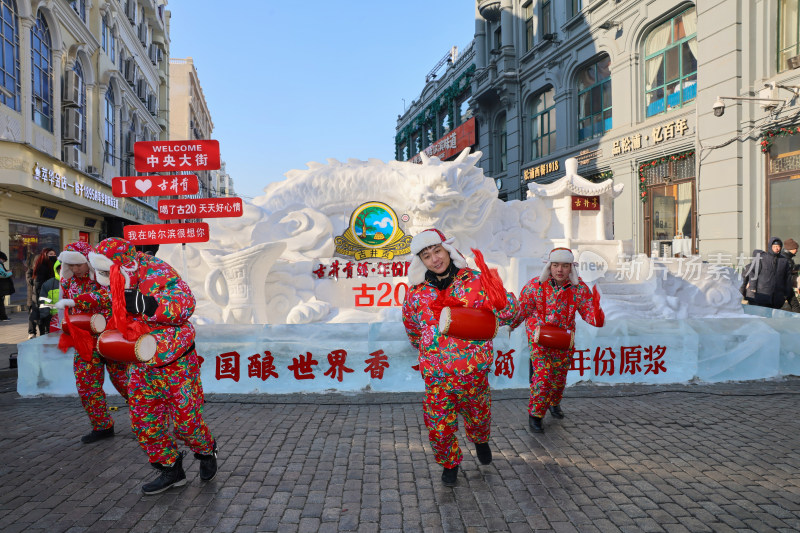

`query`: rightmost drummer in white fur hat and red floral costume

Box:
[513,248,605,433]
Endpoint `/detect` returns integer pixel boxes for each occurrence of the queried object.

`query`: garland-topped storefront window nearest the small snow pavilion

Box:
[644,153,697,257]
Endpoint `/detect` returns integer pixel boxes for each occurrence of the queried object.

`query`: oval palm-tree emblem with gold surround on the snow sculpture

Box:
[333,202,411,261]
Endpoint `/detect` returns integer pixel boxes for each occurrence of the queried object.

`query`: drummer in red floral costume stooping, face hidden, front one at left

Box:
[89,237,217,494]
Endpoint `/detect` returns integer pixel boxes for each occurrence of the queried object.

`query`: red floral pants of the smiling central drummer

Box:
[423,372,492,468]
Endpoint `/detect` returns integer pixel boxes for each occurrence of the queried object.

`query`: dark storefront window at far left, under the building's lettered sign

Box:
[6,220,61,304]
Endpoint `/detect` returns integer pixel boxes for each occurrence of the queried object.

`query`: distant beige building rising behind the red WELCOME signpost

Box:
[169,57,217,198]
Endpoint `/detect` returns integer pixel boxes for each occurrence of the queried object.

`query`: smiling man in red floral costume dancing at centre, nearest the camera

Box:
[403,229,517,487]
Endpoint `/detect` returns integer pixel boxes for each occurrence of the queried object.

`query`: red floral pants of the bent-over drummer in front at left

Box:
[128,350,214,466]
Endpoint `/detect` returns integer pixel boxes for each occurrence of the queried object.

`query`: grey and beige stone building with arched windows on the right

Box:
[398,0,800,264]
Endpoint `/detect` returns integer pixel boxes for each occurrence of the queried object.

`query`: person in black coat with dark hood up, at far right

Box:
[739,237,792,309]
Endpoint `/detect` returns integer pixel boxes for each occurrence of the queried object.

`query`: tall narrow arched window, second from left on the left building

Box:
[31,11,53,131]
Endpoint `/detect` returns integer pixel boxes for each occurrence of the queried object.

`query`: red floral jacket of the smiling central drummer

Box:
[403,268,517,377]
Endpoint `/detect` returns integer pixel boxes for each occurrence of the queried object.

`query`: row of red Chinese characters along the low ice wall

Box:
[208,345,667,383]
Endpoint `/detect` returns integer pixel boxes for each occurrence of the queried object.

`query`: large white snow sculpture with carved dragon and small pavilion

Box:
[159,151,741,324]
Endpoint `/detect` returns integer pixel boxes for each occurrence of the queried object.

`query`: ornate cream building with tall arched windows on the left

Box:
[0,0,170,302]
